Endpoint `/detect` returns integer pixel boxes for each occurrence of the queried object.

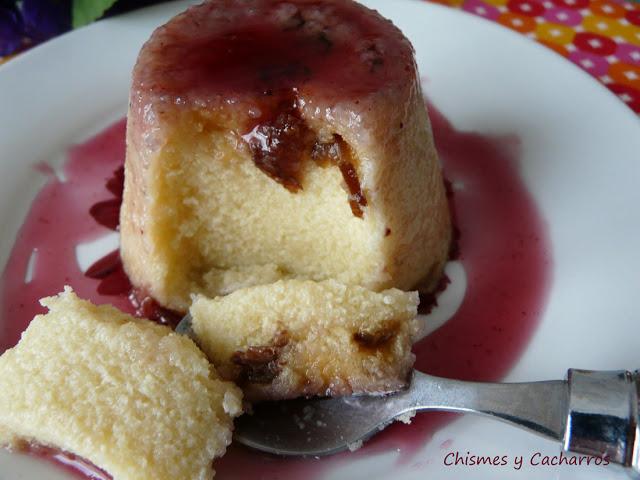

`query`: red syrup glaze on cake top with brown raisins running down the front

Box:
[129,0,402,209]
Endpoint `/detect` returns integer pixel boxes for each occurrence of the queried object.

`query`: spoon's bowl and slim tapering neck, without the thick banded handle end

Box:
[235,372,567,456]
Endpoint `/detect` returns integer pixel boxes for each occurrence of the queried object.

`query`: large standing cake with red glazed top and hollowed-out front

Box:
[121,0,450,312]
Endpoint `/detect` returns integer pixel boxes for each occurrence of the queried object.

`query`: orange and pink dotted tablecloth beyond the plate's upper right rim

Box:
[0,0,640,115]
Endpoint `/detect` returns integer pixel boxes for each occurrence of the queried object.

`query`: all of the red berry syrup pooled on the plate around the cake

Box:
[0,105,551,479]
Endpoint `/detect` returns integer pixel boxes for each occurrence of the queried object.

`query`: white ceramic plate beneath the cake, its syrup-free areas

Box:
[0,0,640,480]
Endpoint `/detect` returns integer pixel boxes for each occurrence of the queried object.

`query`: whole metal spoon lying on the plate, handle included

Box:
[176,316,640,479]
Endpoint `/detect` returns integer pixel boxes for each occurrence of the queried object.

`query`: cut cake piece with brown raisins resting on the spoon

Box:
[190,280,418,401]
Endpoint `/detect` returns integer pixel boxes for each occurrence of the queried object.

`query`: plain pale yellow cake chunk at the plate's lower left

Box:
[0,289,242,480]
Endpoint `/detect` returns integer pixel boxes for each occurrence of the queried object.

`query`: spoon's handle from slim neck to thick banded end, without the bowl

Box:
[403,369,640,479]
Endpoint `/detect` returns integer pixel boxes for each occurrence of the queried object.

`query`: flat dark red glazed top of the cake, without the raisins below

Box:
[132,0,416,108]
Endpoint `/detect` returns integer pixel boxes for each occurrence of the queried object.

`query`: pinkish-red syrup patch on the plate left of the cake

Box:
[0,120,131,351]
